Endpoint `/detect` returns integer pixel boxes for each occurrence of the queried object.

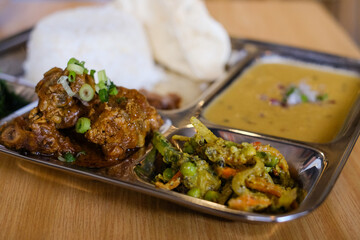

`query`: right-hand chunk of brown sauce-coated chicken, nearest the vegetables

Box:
[85,87,162,165]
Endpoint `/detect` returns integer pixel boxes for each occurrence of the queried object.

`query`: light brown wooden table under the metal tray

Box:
[0,0,360,239]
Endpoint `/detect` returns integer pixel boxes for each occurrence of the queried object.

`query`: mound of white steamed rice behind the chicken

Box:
[24,6,163,89]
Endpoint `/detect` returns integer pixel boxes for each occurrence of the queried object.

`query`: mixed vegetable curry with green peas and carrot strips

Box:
[135,117,304,213]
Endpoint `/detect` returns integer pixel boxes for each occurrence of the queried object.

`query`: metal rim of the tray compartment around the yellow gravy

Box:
[198,49,360,143]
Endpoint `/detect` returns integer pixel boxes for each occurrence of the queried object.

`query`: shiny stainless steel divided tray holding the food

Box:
[0,31,360,222]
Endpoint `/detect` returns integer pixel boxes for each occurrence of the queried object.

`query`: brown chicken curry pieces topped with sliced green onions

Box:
[0,59,163,168]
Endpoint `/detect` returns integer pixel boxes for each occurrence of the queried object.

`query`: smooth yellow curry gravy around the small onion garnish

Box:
[204,63,360,143]
